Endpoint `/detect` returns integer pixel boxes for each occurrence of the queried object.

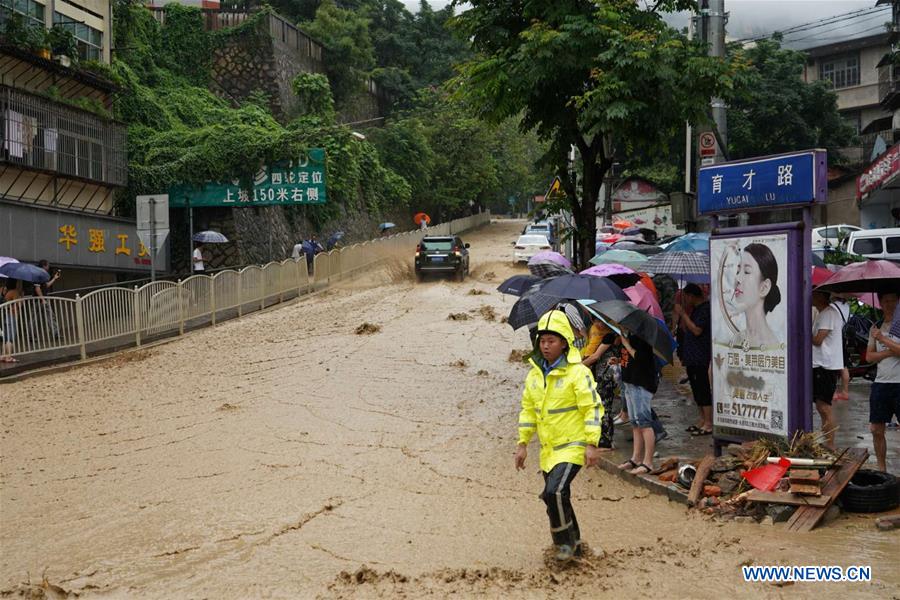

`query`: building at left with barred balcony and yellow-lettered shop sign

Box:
[0,0,166,289]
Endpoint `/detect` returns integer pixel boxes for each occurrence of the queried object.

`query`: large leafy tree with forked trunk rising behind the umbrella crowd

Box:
[455,0,733,262]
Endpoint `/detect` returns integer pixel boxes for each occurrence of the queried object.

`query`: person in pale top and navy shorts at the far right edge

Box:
[866,292,900,471]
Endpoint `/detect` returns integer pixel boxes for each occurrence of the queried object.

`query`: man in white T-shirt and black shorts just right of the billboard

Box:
[812,291,844,449]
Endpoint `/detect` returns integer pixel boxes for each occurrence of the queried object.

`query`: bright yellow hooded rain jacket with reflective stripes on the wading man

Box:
[519,310,603,472]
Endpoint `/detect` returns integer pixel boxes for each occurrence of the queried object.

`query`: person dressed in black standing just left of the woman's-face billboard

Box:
[674,283,712,437]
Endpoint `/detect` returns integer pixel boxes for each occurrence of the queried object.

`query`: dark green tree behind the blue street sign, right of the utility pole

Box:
[728,38,855,164]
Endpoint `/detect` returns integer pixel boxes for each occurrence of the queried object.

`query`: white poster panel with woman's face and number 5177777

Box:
[710,233,789,437]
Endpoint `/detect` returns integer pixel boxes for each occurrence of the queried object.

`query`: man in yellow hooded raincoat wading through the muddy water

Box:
[515,309,603,561]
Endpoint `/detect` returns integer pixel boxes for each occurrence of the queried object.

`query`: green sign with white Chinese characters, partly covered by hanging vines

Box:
[169,148,327,208]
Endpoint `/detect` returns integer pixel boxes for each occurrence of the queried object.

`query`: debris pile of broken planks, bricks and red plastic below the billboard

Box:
[654,433,876,531]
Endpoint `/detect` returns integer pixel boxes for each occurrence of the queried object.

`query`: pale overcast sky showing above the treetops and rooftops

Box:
[403,0,890,47]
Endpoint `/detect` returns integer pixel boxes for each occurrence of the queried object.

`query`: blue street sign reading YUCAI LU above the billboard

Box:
[697,150,828,214]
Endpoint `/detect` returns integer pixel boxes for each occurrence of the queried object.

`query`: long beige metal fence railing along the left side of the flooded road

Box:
[0,212,490,368]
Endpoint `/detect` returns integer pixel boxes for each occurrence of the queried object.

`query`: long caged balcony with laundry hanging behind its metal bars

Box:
[0,85,128,186]
